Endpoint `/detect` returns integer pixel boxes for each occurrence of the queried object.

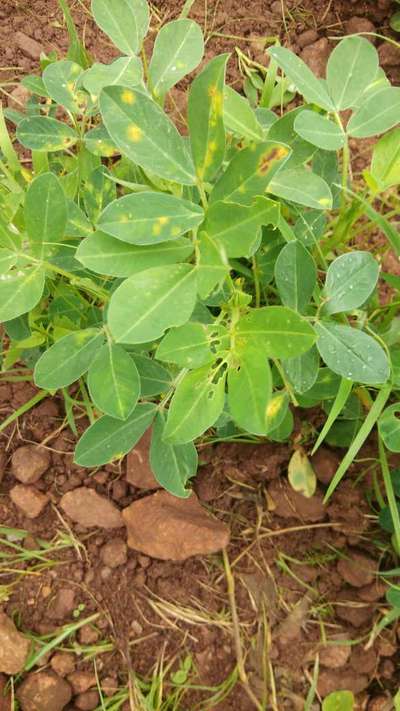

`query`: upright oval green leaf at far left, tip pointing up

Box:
[24,173,68,256]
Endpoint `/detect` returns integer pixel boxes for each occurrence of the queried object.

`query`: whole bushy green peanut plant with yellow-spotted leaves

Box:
[0,0,400,508]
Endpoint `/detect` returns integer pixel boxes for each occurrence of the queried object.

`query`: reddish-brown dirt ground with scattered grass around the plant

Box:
[0,0,400,711]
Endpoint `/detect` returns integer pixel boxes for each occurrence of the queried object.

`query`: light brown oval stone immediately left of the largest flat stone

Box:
[60,486,123,528]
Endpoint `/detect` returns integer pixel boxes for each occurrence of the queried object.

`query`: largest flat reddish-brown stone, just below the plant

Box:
[122,491,230,560]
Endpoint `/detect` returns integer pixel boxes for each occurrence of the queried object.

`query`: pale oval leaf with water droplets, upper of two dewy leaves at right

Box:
[323,251,379,314]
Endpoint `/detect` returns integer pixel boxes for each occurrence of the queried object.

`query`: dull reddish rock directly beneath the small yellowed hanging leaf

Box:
[268,480,326,522]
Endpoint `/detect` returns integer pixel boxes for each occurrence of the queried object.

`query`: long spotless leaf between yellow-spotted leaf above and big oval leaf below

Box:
[75,231,193,277]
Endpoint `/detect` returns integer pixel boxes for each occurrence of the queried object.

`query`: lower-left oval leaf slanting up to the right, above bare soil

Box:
[34,328,104,390]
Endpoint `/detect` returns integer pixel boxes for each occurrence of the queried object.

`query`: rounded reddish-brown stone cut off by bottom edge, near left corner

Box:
[17,672,72,711]
